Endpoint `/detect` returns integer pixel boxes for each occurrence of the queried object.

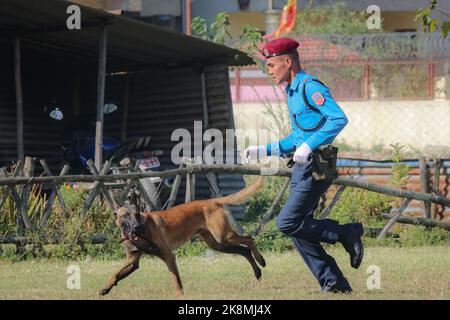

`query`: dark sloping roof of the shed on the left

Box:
[0,0,253,72]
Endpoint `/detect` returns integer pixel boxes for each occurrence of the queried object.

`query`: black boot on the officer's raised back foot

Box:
[338,223,364,269]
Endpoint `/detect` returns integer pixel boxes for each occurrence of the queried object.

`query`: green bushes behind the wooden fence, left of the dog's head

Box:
[0,185,124,261]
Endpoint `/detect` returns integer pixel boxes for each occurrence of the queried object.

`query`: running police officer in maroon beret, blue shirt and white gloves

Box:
[245,38,363,293]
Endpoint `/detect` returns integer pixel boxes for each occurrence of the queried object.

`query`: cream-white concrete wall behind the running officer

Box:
[233,99,450,156]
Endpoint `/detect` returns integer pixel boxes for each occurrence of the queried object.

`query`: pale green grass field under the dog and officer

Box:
[0,246,450,300]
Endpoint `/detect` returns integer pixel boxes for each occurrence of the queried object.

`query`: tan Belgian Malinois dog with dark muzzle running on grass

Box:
[100,177,266,296]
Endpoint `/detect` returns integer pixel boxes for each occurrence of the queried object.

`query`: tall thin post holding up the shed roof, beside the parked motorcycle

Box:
[95,26,107,168]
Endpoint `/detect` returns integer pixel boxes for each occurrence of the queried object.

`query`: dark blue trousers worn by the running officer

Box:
[277,162,347,287]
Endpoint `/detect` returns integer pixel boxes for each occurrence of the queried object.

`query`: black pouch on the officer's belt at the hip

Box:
[312,144,338,181]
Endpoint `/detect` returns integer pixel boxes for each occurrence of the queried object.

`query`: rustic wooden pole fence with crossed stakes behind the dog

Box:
[0,157,450,244]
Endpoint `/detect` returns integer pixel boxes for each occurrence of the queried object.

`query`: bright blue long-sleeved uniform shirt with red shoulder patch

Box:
[266,70,348,156]
